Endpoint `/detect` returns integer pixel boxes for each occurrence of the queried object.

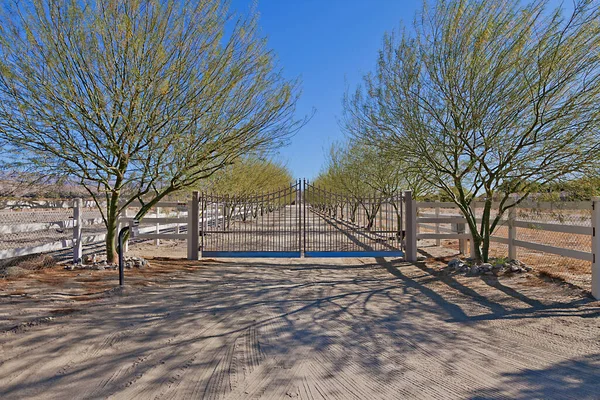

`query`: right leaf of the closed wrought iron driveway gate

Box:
[303,181,404,257]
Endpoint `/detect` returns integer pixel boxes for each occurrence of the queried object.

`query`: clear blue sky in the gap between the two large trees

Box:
[232,0,422,179]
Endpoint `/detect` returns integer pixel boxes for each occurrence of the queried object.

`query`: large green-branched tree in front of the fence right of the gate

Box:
[345,0,600,261]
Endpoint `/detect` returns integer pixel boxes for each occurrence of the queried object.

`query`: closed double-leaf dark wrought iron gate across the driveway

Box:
[200,180,404,258]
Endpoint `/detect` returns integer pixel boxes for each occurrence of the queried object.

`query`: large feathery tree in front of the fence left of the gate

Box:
[0,0,304,261]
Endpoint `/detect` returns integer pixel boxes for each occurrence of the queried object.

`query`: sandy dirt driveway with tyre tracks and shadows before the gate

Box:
[0,259,600,399]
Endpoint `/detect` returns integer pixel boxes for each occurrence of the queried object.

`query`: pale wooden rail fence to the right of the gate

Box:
[406,197,600,299]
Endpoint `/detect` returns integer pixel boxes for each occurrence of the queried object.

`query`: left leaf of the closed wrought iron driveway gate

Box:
[200,181,302,257]
